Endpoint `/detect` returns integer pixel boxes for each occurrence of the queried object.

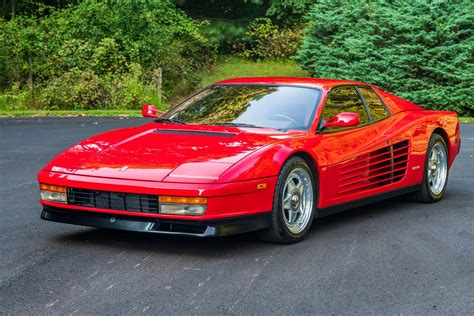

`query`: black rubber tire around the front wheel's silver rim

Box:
[257,157,318,244]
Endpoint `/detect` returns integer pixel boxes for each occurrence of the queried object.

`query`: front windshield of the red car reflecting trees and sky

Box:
[162,85,321,130]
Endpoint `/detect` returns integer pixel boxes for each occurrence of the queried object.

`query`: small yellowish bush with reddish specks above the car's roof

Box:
[242,18,301,59]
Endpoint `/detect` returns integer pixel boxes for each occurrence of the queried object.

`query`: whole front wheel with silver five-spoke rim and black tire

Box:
[257,157,317,244]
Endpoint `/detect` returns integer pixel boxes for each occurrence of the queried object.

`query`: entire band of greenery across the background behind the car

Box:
[0,0,474,115]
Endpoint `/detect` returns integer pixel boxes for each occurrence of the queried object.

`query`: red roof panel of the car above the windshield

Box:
[214,77,368,90]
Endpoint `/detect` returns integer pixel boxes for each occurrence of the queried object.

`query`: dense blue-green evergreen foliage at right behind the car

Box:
[297,0,474,116]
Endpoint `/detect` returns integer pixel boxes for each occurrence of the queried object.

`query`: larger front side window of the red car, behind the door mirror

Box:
[323,86,369,125]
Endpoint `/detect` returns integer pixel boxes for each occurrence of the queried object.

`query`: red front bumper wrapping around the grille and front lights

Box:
[38,170,277,221]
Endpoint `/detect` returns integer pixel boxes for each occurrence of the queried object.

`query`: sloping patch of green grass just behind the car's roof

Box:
[201,56,309,87]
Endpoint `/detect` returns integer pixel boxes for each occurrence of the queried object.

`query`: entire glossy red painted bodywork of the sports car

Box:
[38,77,460,220]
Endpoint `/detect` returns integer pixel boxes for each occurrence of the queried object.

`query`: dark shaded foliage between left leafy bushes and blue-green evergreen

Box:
[175,0,306,55]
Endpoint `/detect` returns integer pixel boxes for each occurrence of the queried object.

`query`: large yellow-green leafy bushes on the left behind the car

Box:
[0,1,214,109]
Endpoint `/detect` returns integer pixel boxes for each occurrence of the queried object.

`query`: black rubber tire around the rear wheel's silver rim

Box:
[412,133,449,203]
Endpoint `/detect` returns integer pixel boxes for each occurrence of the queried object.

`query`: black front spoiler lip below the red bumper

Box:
[41,206,271,237]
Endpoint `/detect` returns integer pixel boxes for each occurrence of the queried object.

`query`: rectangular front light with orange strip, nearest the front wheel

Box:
[158,196,207,215]
